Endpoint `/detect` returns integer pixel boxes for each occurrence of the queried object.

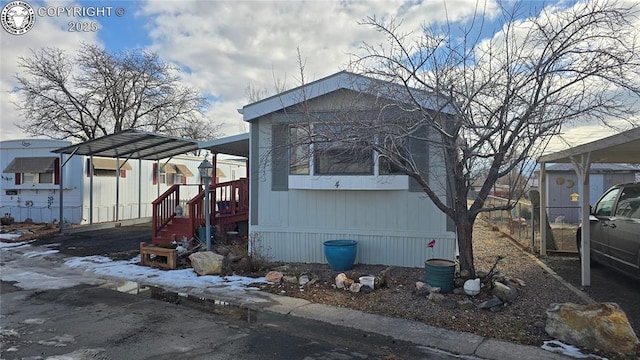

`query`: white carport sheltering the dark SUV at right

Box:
[538,127,640,286]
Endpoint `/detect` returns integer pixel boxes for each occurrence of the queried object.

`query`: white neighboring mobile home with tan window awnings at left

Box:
[0,139,246,224]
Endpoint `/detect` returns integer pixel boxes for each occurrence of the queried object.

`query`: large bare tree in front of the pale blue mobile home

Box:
[280,1,640,274]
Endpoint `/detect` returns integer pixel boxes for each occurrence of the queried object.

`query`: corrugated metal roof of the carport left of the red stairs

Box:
[52,130,199,160]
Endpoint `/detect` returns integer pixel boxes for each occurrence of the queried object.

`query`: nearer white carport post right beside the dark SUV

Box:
[570,153,591,286]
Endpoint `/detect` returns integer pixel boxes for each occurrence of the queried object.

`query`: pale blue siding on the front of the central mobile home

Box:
[250,106,456,267]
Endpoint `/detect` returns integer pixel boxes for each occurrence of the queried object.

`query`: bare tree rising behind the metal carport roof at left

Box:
[11,44,218,141]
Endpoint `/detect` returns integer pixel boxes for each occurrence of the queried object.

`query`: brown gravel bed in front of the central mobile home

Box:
[262,220,640,359]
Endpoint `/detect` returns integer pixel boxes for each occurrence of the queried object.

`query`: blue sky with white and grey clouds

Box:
[0,0,636,155]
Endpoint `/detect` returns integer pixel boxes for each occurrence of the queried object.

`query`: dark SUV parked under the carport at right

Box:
[576,182,640,278]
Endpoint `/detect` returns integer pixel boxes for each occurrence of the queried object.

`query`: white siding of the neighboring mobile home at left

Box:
[0,139,219,224]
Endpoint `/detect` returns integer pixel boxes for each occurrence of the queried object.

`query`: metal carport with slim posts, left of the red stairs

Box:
[52,129,199,232]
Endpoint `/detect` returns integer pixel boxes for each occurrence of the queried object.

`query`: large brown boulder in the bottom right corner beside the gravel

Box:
[545,303,639,354]
